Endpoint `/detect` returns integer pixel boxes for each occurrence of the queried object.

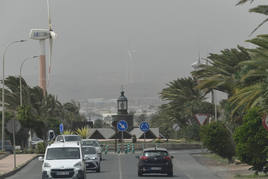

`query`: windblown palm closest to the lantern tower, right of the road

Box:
[160,77,212,127]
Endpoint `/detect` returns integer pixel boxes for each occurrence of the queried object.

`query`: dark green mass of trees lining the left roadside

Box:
[0,76,86,148]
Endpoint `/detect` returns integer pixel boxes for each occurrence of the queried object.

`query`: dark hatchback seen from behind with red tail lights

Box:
[137,148,173,176]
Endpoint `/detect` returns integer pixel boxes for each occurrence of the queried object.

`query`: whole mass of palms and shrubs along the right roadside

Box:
[151,0,268,175]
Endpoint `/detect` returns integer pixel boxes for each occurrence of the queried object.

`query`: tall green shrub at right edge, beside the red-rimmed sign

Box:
[234,108,268,174]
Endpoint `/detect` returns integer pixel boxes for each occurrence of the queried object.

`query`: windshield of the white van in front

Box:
[46,147,80,160]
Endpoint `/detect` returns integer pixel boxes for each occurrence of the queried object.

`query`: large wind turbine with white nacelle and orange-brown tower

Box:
[30,0,56,95]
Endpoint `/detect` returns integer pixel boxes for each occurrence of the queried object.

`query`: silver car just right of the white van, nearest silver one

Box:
[82,146,100,172]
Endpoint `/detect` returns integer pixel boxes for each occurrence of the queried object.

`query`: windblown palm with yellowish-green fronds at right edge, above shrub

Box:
[230,35,268,113]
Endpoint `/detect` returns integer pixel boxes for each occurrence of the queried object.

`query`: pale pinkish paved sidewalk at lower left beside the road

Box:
[0,154,37,175]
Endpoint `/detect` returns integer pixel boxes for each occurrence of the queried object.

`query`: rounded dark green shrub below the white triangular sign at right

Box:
[200,122,235,162]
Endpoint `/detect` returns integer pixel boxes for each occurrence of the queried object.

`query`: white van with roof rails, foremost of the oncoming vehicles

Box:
[39,142,86,179]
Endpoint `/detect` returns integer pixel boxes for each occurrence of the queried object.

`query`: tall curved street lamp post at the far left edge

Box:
[2,40,26,151]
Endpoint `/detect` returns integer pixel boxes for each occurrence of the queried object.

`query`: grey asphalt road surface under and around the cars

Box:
[8,150,224,179]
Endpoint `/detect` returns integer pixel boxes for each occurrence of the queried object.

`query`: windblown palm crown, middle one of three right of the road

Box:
[192,46,250,96]
